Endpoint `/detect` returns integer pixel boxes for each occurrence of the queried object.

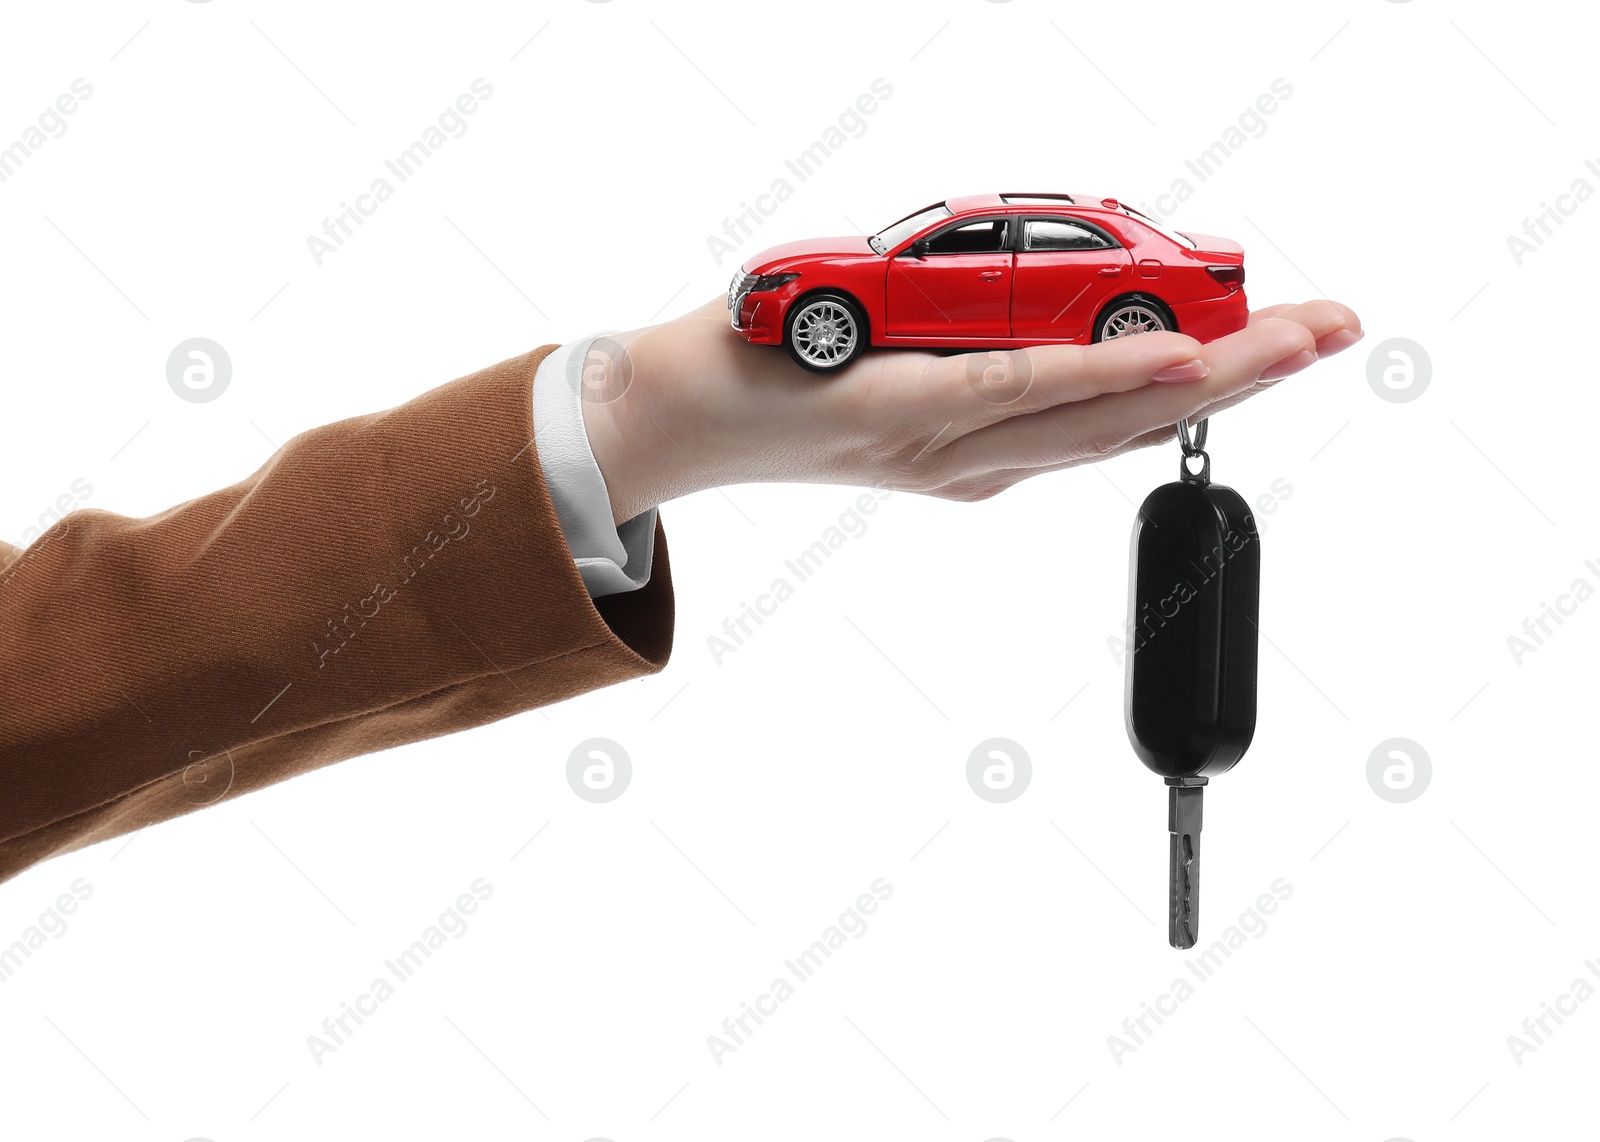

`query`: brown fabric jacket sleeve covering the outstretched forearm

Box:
[0,345,672,880]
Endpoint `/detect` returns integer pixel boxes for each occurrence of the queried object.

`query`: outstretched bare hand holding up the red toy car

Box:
[582,296,1362,523]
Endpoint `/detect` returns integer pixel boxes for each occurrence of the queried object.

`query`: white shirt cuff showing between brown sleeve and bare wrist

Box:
[533,333,656,598]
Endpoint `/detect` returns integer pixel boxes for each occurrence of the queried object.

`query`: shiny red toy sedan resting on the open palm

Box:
[728,194,1248,373]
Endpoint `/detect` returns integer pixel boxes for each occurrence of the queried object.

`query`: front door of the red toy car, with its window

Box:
[885,218,1016,341]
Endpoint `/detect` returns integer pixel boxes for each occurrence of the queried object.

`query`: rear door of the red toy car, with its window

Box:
[1011,218,1133,341]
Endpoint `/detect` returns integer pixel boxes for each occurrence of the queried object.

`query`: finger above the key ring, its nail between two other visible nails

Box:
[930,318,1317,480]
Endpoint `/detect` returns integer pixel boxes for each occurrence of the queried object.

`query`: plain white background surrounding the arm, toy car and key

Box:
[0,0,1600,1142]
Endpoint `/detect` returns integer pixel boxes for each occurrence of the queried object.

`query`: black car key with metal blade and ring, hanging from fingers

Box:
[1123,421,1261,948]
